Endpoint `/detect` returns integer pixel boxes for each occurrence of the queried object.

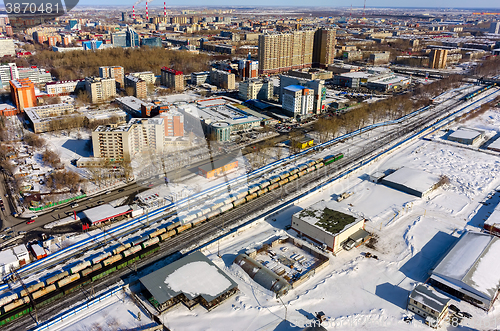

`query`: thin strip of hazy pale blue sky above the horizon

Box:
[74,0,500,8]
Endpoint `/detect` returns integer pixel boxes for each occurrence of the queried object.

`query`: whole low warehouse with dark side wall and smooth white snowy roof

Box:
[380,167,439,198]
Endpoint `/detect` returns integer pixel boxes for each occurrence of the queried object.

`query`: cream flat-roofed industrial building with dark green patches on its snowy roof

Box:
[291,200,369,254]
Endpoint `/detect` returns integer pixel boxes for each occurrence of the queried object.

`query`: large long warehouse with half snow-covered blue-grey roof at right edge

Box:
[430,231,500,311]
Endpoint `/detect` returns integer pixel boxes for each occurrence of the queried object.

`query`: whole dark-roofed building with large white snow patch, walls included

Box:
[139,251,238,312]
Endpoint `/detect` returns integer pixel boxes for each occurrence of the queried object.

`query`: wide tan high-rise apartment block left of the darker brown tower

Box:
[258,30,315,74]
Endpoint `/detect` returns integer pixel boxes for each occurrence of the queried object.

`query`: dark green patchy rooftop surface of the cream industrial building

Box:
[299,207,356,235]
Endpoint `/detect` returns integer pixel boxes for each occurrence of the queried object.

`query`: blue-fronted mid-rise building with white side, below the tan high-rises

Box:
[282,85,314,120]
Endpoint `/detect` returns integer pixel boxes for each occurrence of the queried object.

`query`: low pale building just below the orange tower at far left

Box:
[24,103,75,133]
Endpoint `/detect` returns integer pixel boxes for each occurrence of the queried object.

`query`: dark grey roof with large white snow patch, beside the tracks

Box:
[140,251,238,303]
